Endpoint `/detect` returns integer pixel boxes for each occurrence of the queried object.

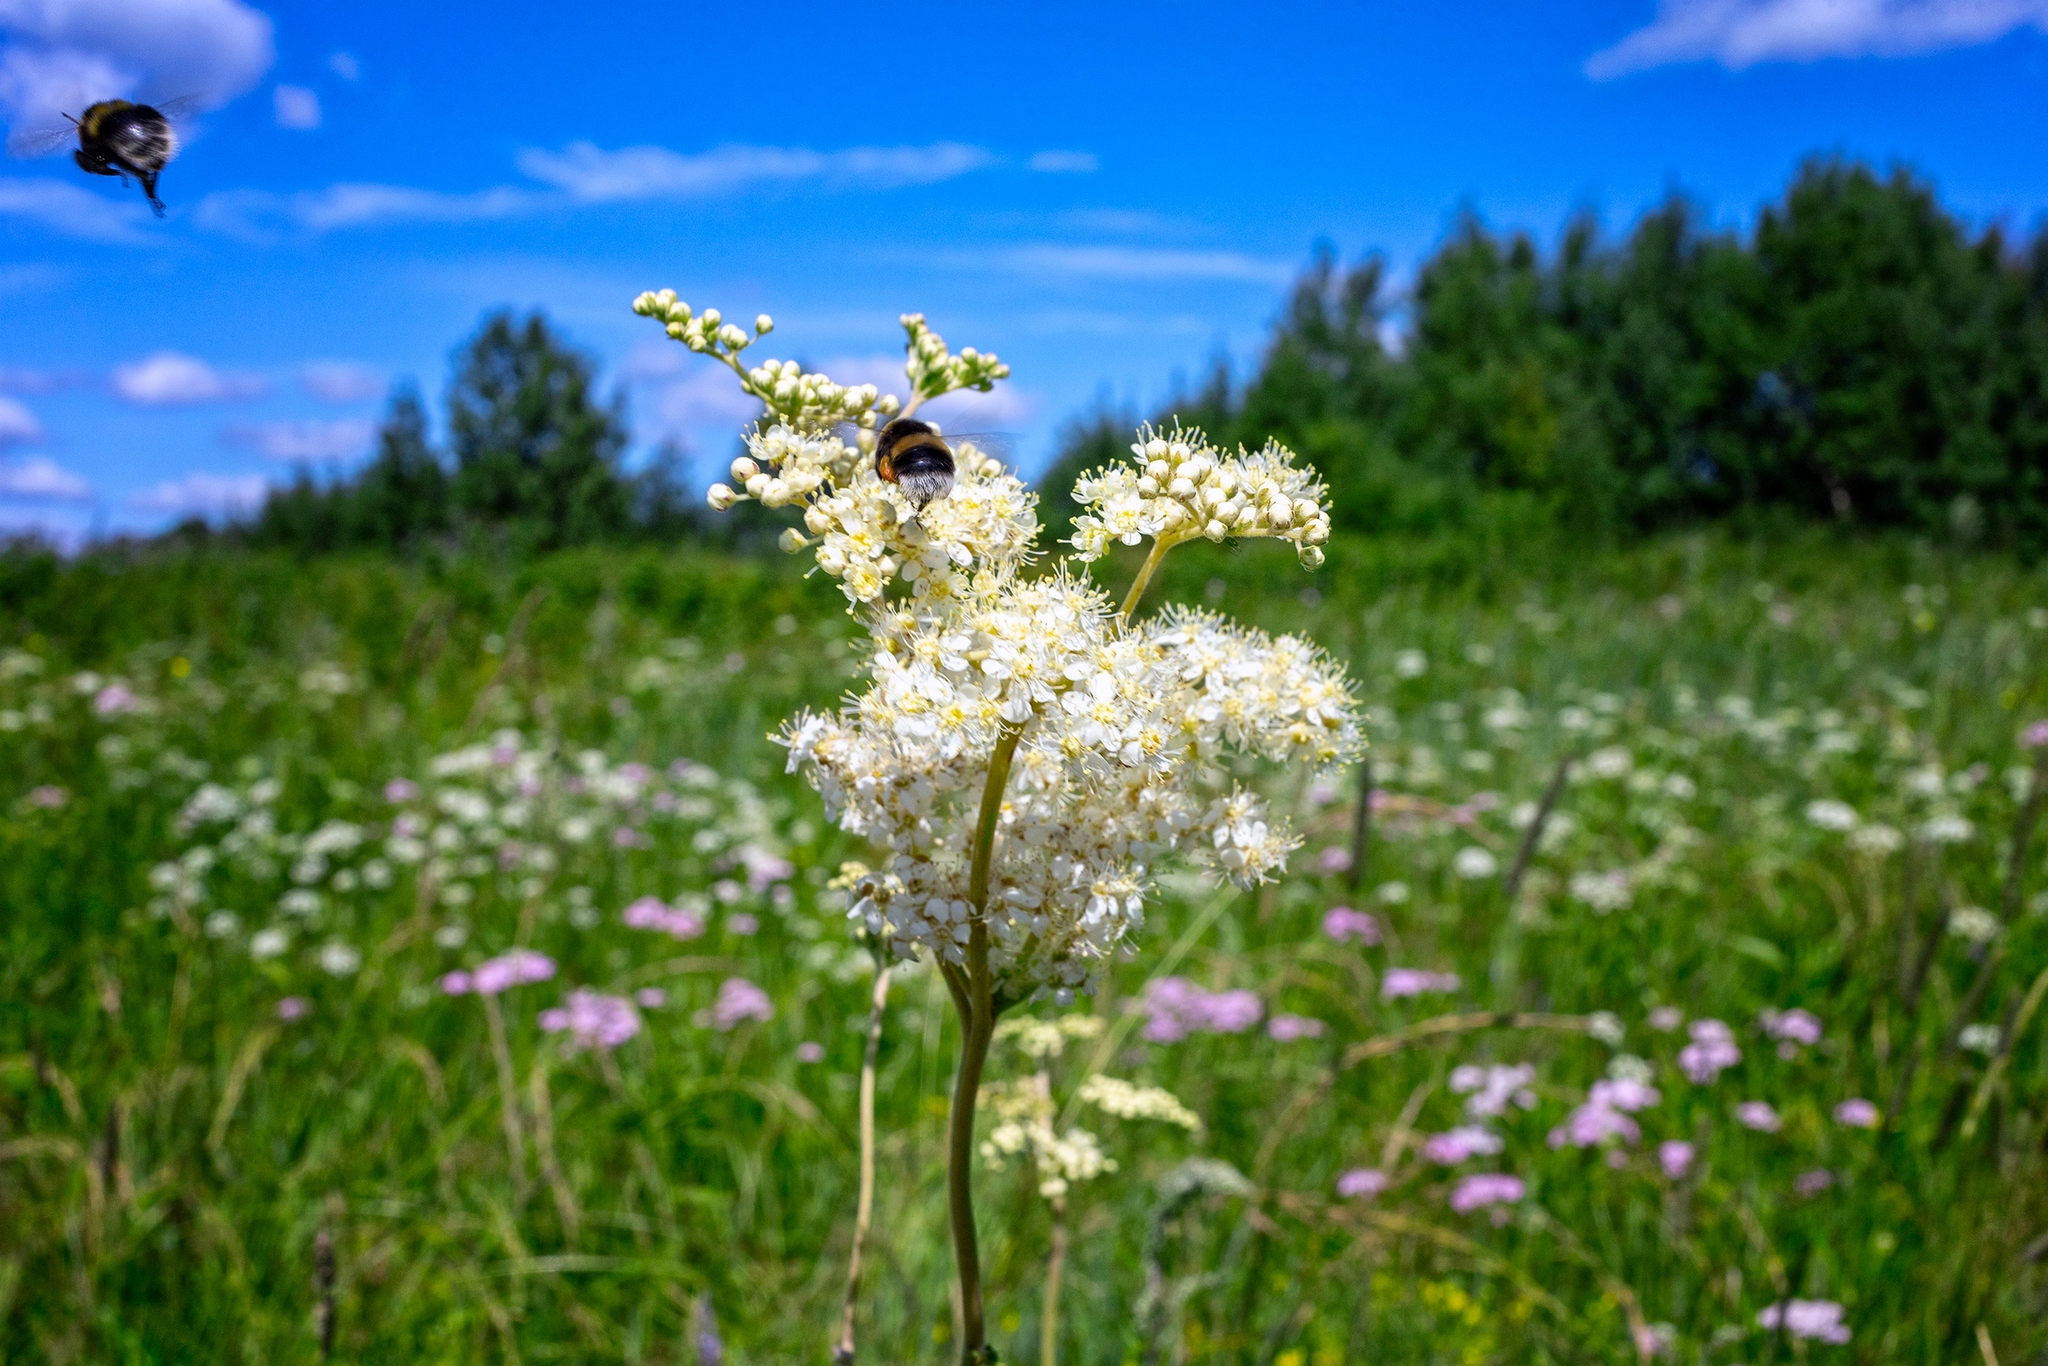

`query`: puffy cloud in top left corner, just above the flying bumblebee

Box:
[0,0,274,147]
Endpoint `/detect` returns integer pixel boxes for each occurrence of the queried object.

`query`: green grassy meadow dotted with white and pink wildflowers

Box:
[0,530,2048,1366]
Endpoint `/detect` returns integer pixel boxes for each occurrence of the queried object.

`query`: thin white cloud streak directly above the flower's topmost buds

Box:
[518,141,995,203]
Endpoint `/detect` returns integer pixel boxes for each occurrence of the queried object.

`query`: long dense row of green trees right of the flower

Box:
[1044,160,2048,553]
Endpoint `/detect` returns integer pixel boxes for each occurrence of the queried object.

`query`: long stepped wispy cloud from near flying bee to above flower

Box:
[195,141,997,240]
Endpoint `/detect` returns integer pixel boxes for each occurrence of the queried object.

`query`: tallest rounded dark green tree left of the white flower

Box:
[449,313,633,551]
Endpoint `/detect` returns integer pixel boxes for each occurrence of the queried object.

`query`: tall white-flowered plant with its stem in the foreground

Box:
[633,291,1364,1362]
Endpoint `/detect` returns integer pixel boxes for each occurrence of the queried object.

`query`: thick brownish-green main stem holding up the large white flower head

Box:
[946,723,1024,1366]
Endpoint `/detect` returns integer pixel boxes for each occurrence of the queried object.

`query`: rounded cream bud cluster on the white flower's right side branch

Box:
[1073,424,1329,569]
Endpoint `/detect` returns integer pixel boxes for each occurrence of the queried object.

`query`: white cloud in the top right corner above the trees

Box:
[1585,0,2048,80]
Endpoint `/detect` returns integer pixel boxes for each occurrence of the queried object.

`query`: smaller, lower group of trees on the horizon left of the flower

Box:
[228,313,700,553]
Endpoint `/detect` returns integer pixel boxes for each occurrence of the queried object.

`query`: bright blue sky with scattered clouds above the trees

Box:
[0,0,2048,539]
